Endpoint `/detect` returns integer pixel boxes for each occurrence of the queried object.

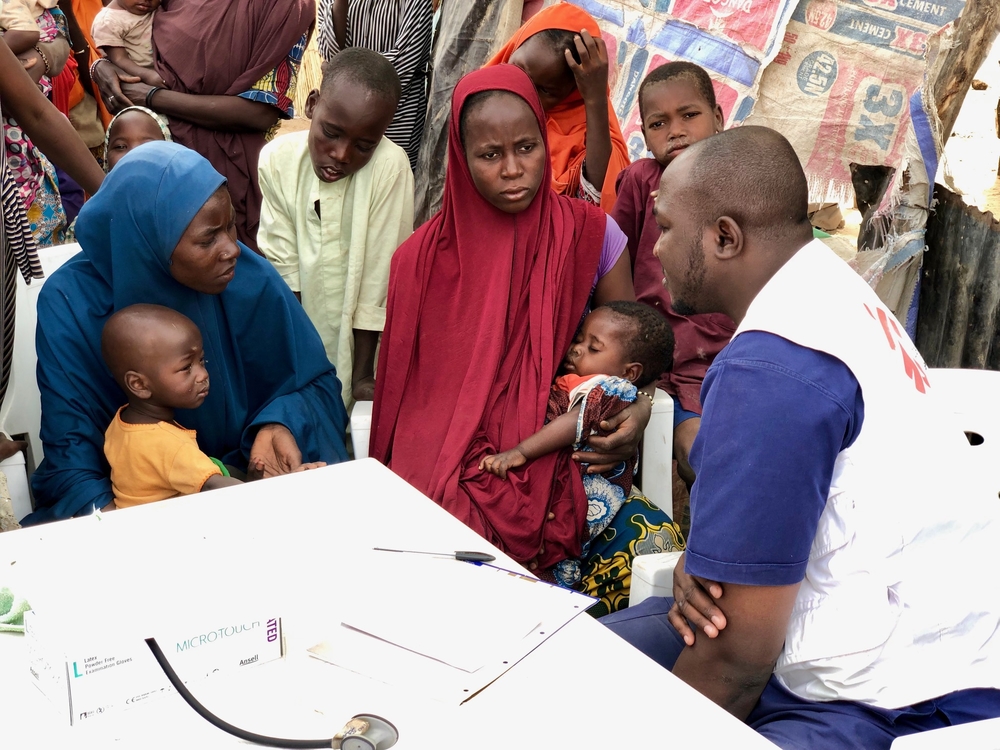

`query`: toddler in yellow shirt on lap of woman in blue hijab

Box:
[101,305,241,508]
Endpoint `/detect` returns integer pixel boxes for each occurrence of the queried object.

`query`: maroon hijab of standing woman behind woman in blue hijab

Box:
[153,0,316,249]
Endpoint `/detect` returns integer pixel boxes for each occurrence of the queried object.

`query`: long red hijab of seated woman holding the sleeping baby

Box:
[371,65,607,567]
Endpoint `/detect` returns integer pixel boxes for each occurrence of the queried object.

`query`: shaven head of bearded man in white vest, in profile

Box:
[653,127,812,321]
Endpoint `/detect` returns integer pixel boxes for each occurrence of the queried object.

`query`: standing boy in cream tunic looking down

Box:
[257,47,413,408]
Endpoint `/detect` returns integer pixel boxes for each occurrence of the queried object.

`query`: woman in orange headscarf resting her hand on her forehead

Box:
[487,3,629,211]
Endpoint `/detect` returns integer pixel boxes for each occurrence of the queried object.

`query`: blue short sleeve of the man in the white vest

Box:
[685,331,864,586]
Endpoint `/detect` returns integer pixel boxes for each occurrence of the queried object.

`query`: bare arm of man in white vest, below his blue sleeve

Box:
[673,583,799,720]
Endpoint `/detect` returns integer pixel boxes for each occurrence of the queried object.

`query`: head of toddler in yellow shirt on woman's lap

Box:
[101,305,208,409]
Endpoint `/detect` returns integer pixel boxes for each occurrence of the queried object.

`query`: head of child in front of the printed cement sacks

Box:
[639,62,725,166]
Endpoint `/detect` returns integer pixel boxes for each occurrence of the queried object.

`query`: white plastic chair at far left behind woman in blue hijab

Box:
[0,243,80,518]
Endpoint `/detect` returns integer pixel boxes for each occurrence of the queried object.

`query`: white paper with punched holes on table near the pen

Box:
[309,558,594,703]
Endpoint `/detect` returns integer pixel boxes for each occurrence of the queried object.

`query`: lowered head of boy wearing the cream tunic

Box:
[306,47,403,182]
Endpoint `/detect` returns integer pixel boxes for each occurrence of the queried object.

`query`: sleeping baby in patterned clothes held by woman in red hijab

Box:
[479,302,674,587]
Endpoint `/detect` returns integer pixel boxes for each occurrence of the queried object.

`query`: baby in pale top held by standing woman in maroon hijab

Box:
[91,0,165,86]
